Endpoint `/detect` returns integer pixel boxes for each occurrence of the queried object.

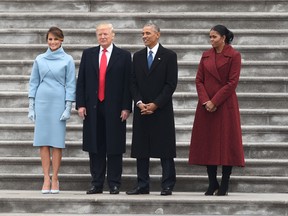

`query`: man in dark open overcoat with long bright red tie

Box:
[76,23,132,194]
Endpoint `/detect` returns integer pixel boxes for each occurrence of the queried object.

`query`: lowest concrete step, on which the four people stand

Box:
[0,190,288,216]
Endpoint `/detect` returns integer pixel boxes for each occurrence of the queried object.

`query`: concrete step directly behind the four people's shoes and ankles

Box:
[0,174,288,193]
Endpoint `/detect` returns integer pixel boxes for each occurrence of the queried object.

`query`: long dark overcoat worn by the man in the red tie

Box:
[76,44,132,154]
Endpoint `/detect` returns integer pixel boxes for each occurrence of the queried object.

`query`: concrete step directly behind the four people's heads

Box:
[0,28,288,45]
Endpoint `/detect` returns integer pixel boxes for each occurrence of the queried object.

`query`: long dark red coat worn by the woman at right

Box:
[189,45,245,166]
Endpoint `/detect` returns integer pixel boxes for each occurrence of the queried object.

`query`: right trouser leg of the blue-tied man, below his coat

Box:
[161,158,176,190]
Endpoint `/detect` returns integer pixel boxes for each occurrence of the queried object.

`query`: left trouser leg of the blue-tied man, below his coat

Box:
[137,158,150,189]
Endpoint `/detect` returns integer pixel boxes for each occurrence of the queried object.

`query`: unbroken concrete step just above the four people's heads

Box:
[0,11,288,29]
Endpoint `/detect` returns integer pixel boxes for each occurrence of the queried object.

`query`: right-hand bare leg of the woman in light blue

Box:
[51,148,62,190]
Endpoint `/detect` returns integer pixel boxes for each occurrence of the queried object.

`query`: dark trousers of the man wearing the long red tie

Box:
[89,101,123,188]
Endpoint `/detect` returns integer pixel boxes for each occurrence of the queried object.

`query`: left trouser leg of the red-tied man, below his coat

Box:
[89,153,106,188]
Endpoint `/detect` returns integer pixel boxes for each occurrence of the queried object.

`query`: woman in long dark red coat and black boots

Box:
[189,25,245,196]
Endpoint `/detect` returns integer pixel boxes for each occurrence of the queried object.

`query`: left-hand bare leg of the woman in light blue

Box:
[40,146,50,190]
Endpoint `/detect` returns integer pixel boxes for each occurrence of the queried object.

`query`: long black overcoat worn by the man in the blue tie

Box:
[131,44,178,158]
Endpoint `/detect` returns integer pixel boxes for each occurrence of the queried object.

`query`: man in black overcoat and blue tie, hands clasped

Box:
[127,23,178,195]
